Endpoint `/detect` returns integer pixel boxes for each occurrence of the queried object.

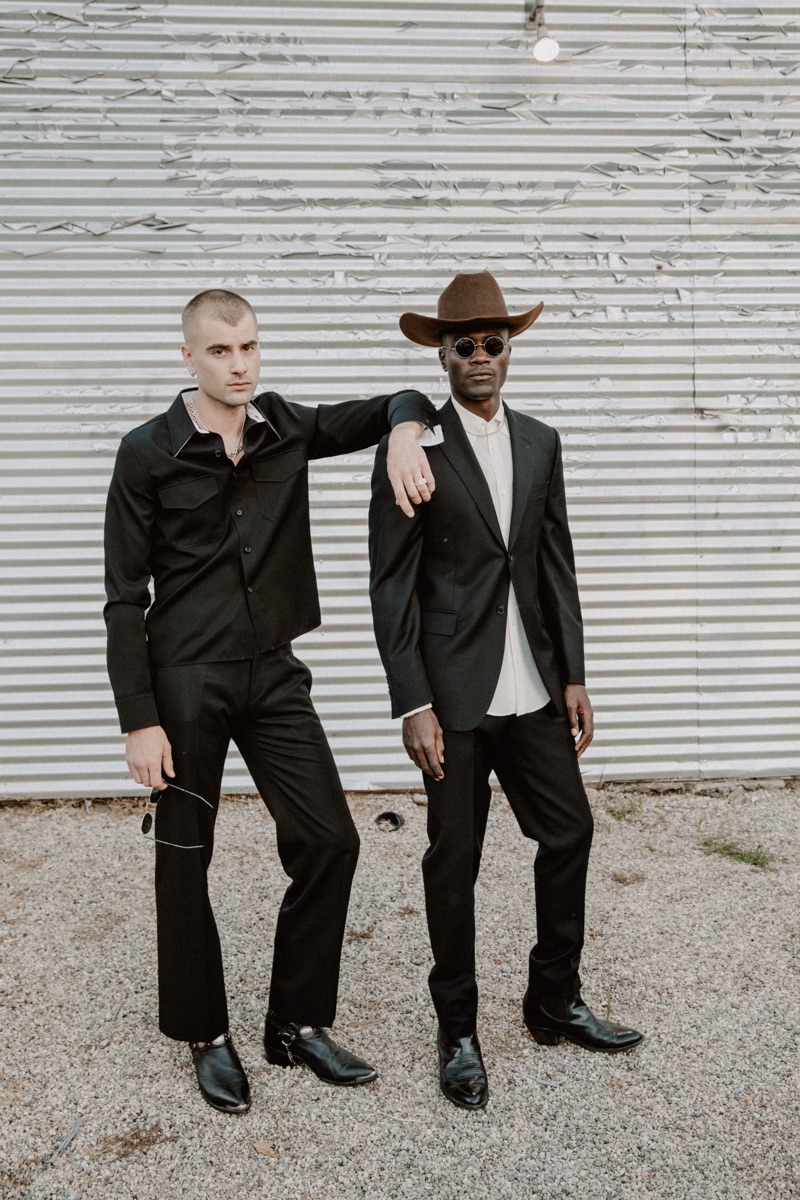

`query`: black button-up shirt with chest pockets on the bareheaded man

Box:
[104,389,437,732]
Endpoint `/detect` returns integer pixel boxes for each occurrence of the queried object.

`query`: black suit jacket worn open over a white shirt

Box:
[369,400,584,730]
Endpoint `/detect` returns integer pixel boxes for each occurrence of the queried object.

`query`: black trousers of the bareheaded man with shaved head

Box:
[149,646,359,1042]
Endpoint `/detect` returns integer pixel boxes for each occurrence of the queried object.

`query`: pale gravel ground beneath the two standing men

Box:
[0,780,800,1200]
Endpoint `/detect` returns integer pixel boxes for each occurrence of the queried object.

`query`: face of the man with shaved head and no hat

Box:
[181,312,261,408]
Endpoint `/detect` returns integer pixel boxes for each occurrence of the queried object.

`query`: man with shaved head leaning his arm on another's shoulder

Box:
[106,288,435,1112]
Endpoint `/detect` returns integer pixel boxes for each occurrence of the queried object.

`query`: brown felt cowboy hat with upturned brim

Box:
[399,271,545,346]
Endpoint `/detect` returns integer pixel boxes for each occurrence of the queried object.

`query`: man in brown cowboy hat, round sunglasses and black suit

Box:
[369,271,642,1109]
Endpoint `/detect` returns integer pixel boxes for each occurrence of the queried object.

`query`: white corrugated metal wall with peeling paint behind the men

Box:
[0,0,800,796]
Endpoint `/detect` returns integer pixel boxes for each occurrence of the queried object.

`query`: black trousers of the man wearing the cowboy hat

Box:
[422,704,594,1038]
